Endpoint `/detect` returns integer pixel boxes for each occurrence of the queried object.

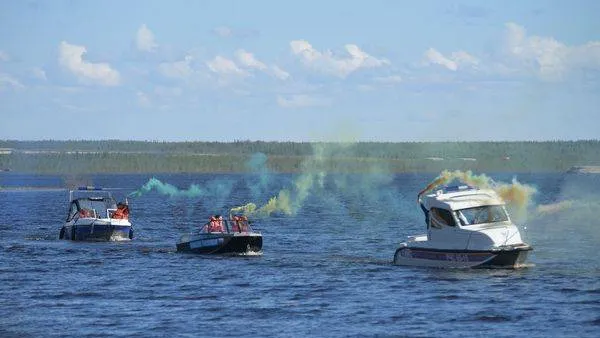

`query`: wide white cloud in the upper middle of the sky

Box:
[290,40,390,78]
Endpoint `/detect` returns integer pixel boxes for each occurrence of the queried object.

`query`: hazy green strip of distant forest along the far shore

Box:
[0,140,600,174]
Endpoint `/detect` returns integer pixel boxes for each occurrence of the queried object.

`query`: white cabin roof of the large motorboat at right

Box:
[421,185,504,210]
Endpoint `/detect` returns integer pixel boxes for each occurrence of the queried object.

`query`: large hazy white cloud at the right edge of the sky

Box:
[505,22,600,80]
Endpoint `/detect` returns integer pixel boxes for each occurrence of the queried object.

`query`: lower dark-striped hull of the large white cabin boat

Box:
[394,245,532,269]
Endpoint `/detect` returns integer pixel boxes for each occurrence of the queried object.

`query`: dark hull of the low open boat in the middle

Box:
[177,233,262,254]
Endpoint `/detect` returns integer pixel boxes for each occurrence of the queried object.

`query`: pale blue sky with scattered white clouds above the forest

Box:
[0,0,600,142]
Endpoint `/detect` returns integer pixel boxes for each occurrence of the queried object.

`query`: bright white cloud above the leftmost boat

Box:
[58,41,120,86]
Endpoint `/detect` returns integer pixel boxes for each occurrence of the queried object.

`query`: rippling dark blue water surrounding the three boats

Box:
[0,173,600,337]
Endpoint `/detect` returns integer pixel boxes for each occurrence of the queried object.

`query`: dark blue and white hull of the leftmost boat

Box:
[59,223,133,242]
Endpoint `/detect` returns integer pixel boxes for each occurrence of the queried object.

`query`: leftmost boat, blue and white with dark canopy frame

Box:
[59,187,133,241]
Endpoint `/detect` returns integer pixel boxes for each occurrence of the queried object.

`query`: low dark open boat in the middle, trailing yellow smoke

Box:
[177,215,262,255]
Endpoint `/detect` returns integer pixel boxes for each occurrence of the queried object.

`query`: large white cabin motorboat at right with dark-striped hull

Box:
[394,185,532,268]
